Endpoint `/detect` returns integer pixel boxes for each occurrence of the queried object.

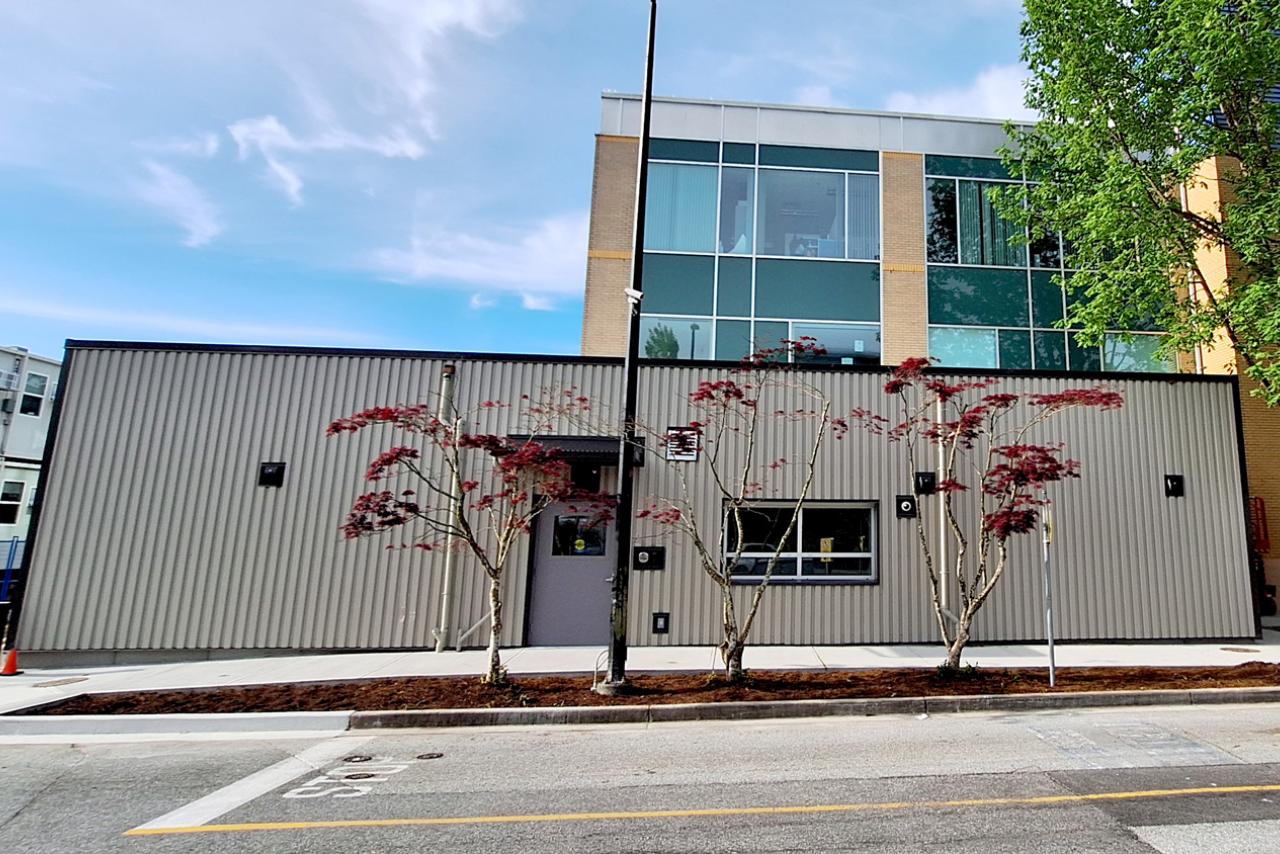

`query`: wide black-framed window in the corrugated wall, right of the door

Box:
[724,502,876,583]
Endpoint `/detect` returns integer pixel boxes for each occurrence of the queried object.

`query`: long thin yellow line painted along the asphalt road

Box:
[124,784,1280,836]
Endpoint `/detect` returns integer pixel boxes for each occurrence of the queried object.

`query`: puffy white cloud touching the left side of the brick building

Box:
[371,213,588,310]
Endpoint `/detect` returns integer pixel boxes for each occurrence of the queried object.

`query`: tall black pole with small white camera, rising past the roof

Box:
[604,0,658,691]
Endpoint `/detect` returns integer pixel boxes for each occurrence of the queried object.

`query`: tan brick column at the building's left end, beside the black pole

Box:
[582,134,640,356]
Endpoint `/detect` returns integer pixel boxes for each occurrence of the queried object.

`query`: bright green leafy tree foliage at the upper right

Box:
[1000,0,1280,405]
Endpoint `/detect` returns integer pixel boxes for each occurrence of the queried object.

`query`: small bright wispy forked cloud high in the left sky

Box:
[227,115,424,206]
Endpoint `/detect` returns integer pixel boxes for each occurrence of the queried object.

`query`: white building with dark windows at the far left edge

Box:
[0,347,61,540]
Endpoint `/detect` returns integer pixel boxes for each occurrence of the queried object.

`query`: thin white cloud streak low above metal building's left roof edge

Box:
[0,292,376,344]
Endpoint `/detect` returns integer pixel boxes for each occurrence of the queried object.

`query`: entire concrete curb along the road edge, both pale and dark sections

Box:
[0,686,1280,736]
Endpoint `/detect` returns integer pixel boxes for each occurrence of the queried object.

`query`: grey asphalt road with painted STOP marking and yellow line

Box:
[0,705,1280,854]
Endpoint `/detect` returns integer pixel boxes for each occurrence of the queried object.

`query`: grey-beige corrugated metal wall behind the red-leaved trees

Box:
[22,347,1253,650]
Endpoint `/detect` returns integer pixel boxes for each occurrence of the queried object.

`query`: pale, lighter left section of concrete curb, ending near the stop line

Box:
[0,712,351,735]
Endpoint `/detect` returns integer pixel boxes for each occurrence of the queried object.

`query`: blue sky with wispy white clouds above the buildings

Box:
[0,0,1027,356]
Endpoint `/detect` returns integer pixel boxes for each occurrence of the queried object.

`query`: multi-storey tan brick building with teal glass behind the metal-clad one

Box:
[582,93,1280,594]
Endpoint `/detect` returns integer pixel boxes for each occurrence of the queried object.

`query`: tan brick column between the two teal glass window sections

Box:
[881,151,929,365]
